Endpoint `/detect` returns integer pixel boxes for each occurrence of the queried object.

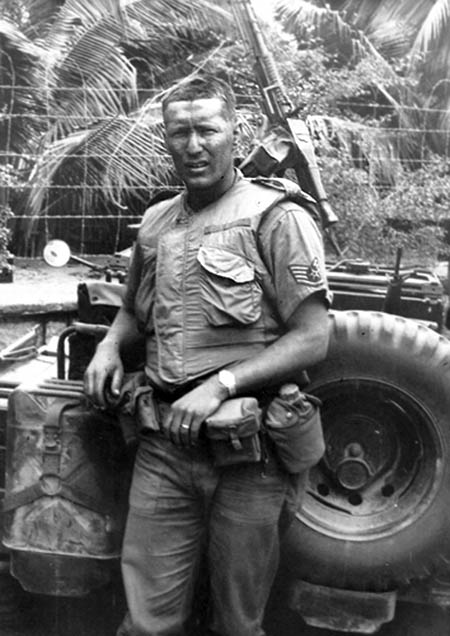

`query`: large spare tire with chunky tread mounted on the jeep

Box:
[282,311,450,591]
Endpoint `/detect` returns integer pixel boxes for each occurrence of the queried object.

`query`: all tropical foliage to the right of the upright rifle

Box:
[277,0,450,258]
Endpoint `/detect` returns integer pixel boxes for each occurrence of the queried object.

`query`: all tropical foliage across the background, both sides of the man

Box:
[0,0,450,258]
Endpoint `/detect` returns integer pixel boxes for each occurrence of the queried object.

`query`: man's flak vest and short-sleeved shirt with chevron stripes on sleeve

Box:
[119,180,329,386]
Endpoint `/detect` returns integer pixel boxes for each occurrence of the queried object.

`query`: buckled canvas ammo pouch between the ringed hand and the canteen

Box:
[206,397,262,466]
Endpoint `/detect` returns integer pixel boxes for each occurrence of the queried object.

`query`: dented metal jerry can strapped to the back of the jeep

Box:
[3,379,130,596]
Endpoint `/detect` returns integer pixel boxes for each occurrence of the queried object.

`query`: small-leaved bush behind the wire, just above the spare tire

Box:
[322,157,450,266]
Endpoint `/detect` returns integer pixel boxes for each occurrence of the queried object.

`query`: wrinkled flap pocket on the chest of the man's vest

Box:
[197,246,262,327]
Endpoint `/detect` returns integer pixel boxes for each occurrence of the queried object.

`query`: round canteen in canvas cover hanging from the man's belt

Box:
[265,385,325,474]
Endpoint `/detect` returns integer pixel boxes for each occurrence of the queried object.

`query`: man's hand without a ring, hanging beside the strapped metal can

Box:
[84,339,124,408]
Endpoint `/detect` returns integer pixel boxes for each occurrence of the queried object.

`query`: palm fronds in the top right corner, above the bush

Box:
[277,0,450,165]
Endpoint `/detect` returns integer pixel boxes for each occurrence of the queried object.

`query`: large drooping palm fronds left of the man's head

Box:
[0,0,237,253]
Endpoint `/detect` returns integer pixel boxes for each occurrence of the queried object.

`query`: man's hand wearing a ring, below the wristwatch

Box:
[162,376,228,446]
